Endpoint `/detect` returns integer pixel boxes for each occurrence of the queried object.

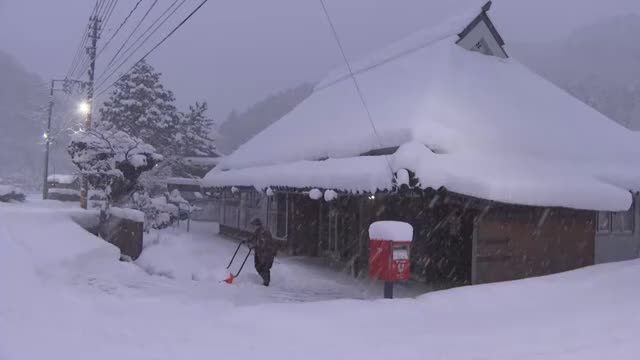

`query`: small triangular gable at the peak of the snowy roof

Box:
[456,1,509,59]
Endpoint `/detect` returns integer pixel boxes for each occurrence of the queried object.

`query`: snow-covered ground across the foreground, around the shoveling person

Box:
[0,198,640,360]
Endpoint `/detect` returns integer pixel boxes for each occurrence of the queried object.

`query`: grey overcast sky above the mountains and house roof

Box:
[0,0,640,120]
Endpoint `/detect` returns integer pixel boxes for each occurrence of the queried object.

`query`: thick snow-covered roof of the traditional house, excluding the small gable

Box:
[203,2,640,210]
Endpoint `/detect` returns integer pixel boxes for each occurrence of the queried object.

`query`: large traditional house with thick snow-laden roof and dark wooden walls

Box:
[202,1,640,285]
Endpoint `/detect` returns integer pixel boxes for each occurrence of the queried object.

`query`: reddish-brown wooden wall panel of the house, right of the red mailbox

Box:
[474,206,595,283]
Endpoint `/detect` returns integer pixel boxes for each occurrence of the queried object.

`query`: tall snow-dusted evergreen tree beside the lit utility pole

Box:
[98,60,180,154]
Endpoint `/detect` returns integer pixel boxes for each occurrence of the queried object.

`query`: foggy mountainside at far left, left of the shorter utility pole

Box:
[0,51,70,190]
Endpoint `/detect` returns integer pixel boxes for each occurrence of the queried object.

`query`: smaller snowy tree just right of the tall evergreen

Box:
[176,102,216,156]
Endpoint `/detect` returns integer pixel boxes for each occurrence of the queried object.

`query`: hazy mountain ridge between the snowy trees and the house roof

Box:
[217,83,314,154]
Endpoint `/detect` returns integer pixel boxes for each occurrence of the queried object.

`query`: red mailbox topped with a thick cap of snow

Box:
[369,221,413,282]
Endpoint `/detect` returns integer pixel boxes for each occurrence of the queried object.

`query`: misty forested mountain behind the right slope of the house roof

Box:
[509,15,640,130]
